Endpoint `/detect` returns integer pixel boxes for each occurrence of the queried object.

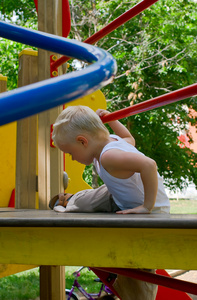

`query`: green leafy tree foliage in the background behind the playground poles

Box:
[1,0,197,189]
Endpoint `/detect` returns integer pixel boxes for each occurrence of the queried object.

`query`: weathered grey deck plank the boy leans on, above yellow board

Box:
[0,208,197,229]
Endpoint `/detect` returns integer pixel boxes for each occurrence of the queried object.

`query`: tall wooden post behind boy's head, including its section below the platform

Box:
[38,0,65,300]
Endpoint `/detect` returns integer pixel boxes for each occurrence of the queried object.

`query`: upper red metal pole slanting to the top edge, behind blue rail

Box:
[54,0,158,68]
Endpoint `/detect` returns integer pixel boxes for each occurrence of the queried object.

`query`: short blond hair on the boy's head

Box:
[52,105,109,146]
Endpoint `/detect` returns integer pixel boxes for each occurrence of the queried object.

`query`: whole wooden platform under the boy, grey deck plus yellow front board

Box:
[0,209,197,270]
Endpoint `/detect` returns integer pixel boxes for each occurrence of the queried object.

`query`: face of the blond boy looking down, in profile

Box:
[59,140,94,166]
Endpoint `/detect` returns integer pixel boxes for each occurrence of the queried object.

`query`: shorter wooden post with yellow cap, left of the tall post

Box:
[15,49,38,208]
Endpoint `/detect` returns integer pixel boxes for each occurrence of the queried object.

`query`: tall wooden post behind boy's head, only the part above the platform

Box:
[38,0,64,209]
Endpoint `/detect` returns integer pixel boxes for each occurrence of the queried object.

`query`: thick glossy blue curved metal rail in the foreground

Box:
[0,22,117,125]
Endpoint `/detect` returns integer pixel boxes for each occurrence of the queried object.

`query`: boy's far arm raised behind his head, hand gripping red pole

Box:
[96,109,135,146]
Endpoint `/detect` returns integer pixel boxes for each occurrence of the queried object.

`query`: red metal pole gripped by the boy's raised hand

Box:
[101,83,197,123]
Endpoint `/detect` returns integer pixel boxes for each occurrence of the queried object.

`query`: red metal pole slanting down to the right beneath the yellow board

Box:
[96,268,197,295]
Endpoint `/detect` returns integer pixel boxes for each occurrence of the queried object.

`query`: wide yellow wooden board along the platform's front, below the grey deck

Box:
[0,227,197,270]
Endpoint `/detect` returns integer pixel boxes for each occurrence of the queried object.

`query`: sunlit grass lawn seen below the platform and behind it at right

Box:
[0,200,197,300]
